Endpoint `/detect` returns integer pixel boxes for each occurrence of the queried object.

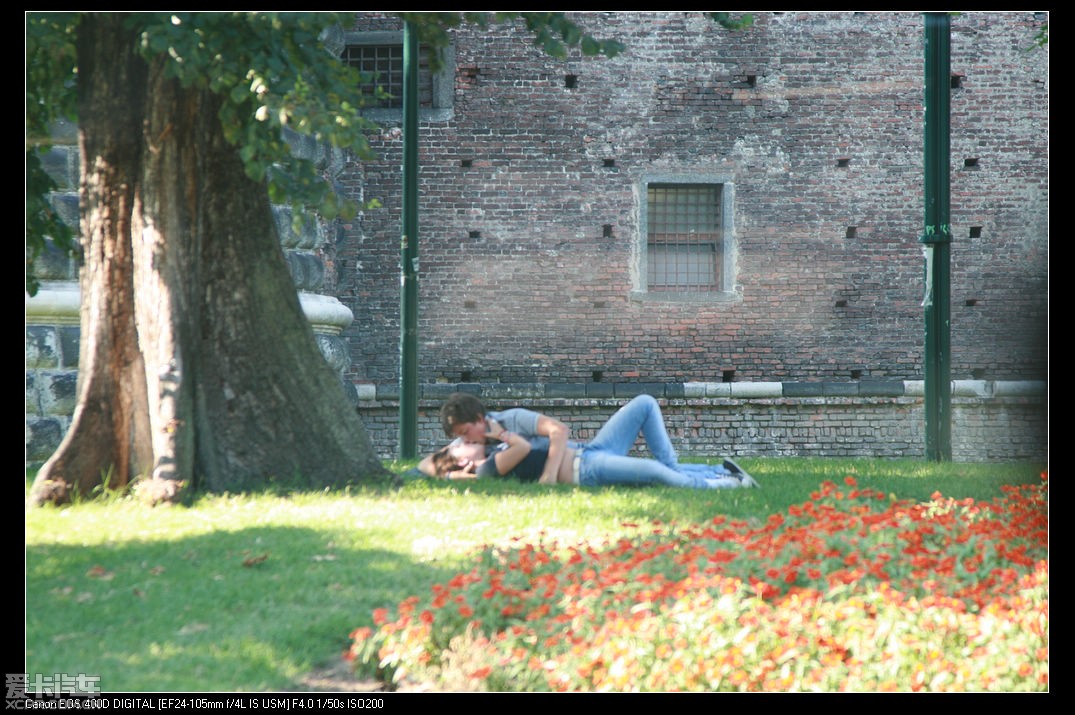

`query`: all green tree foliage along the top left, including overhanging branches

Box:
[26,12,622,295]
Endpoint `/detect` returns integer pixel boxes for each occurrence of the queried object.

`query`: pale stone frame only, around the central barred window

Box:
[631,172,742,303]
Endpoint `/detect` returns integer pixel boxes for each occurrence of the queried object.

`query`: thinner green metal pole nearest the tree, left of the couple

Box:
[399,22,418,459]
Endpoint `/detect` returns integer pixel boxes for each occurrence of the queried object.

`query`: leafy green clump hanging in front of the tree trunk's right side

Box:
[135,13,377,220]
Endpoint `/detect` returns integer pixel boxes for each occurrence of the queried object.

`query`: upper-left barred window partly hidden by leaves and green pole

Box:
[341,31,455,120]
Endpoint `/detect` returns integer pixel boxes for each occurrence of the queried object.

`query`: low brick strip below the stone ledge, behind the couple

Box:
[359,394,1048,463]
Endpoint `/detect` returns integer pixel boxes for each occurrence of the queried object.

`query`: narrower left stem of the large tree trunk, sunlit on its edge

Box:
[31,14,153,502]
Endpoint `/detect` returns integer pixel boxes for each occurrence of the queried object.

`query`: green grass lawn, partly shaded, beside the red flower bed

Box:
[26,459,1045,692]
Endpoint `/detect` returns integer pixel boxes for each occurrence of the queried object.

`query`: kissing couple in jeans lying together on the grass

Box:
[418,392,758,489]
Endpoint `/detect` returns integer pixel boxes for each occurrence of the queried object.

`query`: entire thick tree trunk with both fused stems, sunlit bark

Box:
[31,13,388,503]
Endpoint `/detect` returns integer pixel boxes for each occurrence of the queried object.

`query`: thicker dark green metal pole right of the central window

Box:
[920,13,951,461]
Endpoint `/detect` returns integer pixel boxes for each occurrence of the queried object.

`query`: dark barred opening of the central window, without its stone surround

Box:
[646,184,725,292]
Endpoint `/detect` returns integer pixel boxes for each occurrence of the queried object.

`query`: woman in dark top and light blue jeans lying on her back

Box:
[418,395,758,489]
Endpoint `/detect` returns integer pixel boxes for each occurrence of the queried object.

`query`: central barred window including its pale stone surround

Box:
[636,176,734,299]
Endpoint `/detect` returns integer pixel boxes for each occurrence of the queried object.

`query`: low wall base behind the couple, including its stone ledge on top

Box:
[358,381,1048,463]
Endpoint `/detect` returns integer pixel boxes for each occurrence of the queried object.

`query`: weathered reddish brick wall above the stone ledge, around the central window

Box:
[338,12,1048,385]
